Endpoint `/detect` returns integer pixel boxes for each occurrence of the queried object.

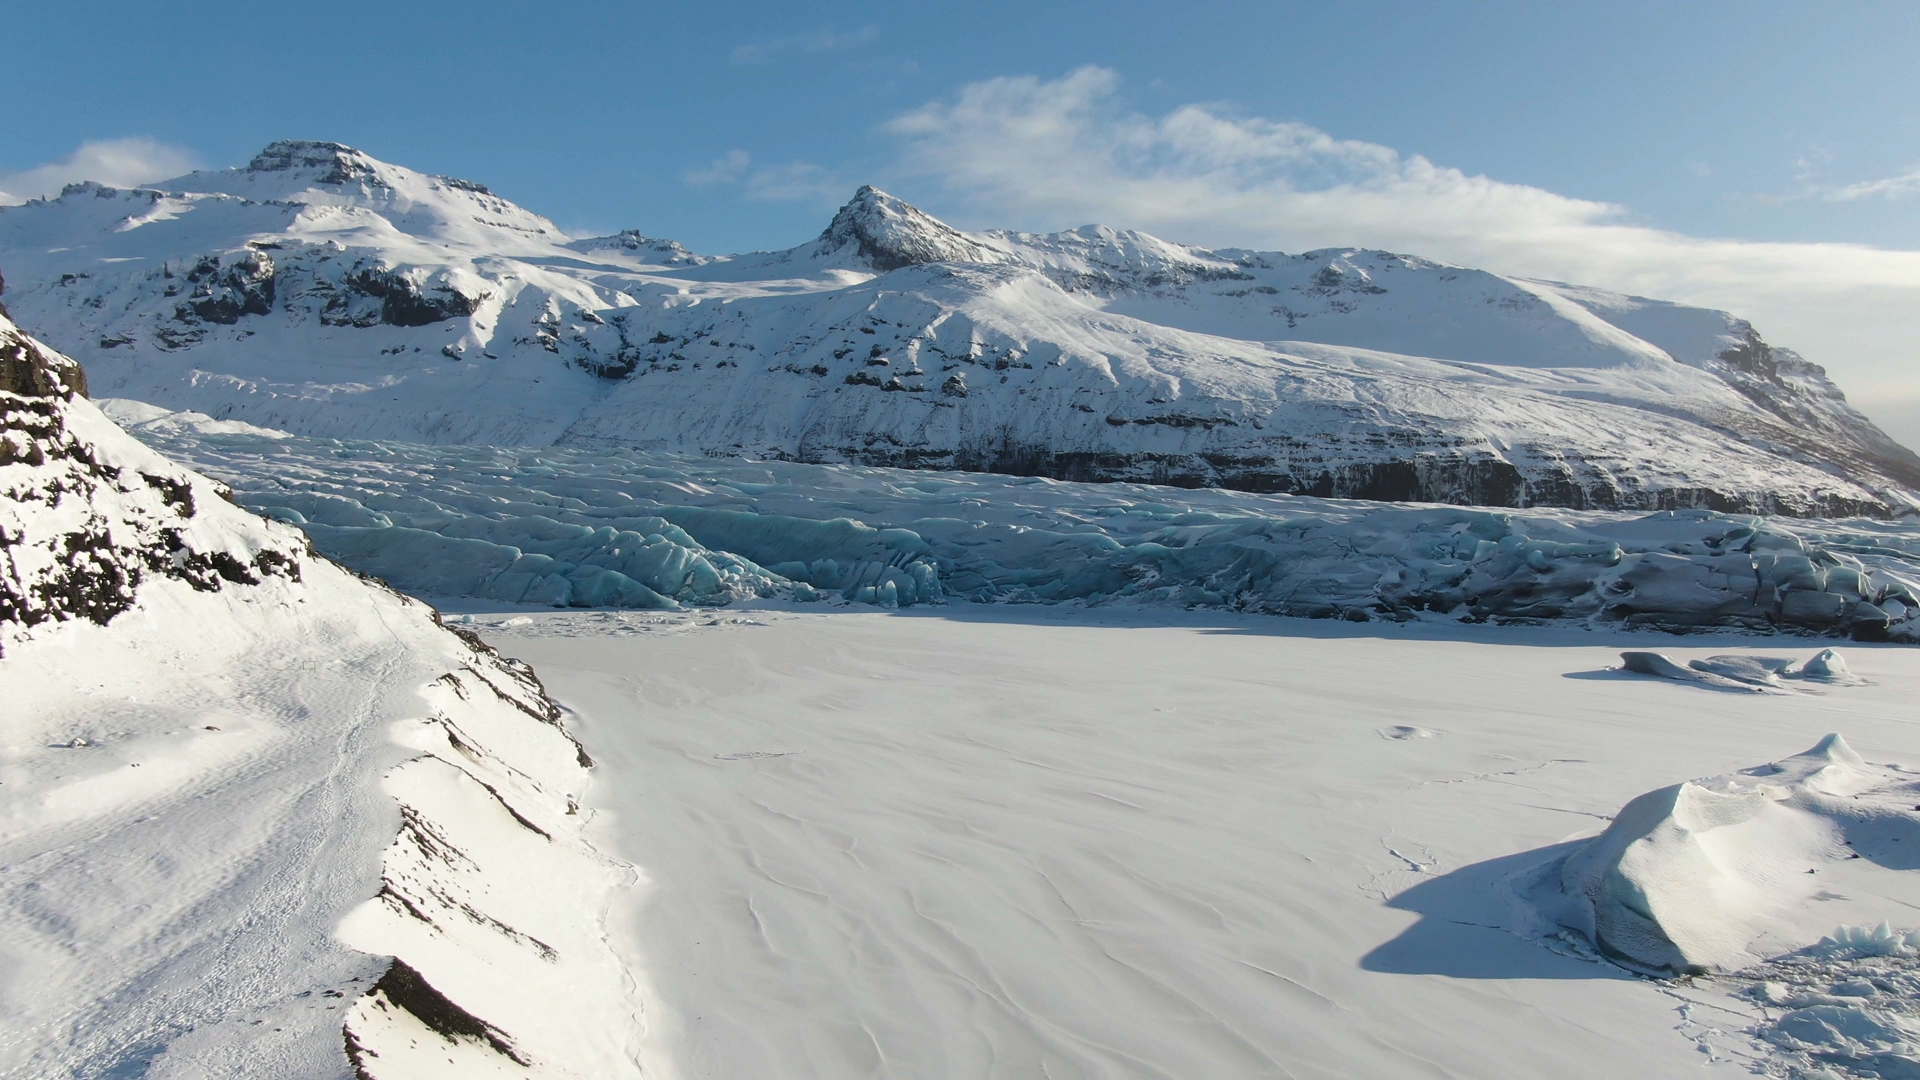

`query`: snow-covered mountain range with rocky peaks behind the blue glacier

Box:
[0,142,1920,515]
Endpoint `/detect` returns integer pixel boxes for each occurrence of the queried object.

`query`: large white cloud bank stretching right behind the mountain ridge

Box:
[885,67,1920,409]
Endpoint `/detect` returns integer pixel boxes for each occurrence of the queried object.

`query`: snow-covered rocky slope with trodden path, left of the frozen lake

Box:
[0,309,637,1080]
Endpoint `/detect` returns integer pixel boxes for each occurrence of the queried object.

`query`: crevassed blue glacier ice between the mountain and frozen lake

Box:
[106,402,1920,642]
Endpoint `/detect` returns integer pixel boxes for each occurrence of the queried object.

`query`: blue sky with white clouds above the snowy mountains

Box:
[0,2,1920,434]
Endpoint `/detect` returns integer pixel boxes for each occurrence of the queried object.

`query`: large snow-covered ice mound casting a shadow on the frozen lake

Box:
[1534,734,1920,974]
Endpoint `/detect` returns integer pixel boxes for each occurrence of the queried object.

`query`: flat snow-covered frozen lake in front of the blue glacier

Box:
[476,603,1920,1078]
